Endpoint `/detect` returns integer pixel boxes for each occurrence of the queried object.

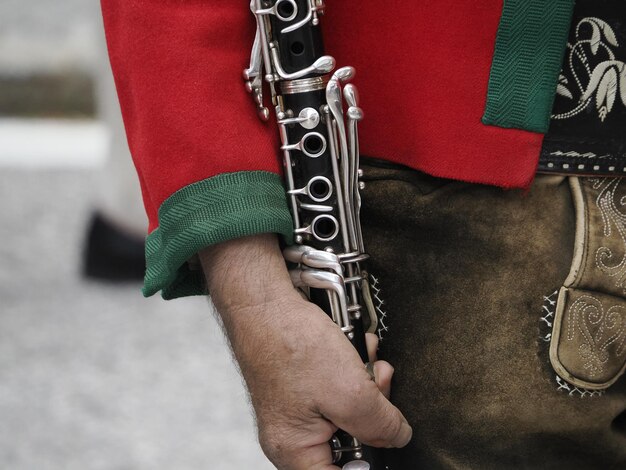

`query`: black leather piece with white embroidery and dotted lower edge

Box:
[538,0,626,176]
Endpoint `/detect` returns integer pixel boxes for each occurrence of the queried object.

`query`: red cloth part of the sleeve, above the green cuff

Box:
[102,0,280,231]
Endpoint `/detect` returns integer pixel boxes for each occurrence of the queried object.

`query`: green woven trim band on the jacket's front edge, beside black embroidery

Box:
[482,0,574,133]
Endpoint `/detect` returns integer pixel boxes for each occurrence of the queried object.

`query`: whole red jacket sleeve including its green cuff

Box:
[102,0,293,298]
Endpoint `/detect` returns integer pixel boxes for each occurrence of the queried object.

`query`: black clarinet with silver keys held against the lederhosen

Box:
[244,0,387,470]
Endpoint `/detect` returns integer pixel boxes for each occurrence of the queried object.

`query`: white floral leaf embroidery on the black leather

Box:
[552,17,626,122]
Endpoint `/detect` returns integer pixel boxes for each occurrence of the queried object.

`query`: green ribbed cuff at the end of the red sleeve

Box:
[143,171,293,299]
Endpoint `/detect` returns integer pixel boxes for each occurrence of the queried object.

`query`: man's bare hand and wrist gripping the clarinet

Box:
[201,235,412,470]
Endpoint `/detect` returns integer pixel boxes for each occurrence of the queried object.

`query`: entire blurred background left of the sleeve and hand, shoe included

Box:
[0,0,273,470]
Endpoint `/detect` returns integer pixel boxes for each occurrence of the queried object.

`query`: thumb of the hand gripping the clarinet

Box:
[325,380,413,447]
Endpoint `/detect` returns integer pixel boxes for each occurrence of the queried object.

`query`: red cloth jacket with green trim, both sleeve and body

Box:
[102,0,573,298]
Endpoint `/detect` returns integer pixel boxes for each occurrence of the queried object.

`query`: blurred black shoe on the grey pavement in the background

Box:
[83,212,146,282]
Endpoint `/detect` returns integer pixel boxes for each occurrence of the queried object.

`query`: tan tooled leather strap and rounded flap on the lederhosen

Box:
[550,178,626,390]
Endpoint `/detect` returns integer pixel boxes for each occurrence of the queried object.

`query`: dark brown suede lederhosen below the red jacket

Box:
[363,161,626,470]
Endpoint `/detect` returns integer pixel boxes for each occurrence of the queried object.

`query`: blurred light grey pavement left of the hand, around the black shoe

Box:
[0,168,273,470]
